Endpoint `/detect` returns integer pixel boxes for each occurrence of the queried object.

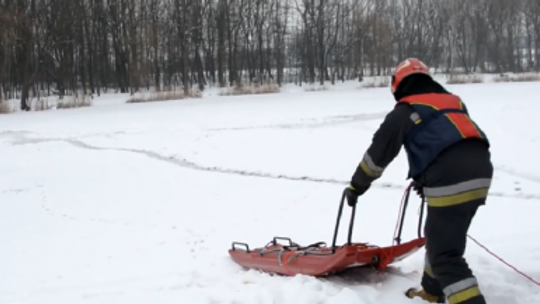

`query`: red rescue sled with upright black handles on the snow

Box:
[229,186,425,277]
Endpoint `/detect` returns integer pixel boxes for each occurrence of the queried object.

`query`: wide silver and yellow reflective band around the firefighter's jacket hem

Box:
[423,178,491,207]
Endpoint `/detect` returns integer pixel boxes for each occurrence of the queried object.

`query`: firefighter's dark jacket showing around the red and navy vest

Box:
[351,75,493,205]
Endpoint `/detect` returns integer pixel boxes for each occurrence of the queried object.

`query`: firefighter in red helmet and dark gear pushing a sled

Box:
[345,58,493,304]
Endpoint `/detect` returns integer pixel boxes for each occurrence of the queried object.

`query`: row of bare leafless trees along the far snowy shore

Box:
[0,0,540,109]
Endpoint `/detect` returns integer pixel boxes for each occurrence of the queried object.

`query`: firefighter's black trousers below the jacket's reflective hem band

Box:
[422,201,486,304]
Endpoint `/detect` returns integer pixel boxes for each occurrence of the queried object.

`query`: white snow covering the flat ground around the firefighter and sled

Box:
[0,83,540,304]
